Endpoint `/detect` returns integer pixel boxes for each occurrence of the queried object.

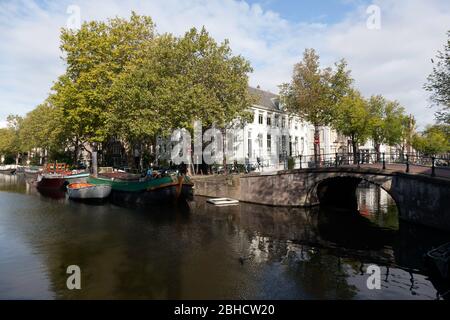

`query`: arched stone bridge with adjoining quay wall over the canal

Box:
[194,166,450,231]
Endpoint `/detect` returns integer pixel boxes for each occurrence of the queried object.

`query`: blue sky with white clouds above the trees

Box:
[0,0,450,128]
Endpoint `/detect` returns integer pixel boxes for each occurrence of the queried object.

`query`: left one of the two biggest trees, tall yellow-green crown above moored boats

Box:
[49,12,155,168]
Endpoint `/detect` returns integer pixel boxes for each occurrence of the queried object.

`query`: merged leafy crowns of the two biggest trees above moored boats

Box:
[44,13,253,169]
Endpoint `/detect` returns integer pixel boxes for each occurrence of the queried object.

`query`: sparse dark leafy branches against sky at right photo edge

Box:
[424,31,450,124]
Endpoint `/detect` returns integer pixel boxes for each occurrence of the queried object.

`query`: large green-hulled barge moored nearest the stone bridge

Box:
[88,175,194,206]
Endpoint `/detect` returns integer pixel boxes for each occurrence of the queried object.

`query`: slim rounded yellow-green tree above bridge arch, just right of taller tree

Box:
[333,90,371,163]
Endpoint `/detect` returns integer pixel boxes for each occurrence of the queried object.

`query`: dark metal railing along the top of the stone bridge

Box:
[281,152,450,178]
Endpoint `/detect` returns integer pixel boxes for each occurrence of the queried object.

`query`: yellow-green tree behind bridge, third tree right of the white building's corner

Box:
[367,95,405,160]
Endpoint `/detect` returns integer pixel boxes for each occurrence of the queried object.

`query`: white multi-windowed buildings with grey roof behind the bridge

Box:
[156,87,386,168]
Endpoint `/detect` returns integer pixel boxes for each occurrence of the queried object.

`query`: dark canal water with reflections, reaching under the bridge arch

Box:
[0,175,450,299]
